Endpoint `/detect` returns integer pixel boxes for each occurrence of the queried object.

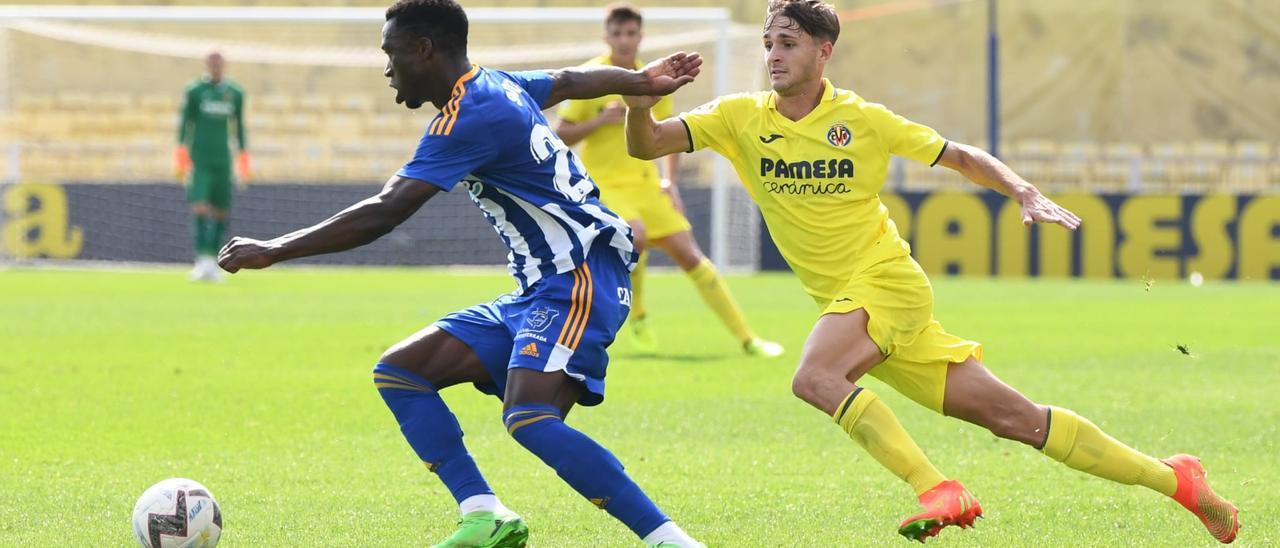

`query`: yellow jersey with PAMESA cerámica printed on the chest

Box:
[680,78,946,302]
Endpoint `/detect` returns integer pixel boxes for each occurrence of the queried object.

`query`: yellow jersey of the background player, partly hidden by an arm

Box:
[558,54,672,192]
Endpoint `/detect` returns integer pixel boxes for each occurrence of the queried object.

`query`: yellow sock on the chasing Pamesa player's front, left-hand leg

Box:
[833,388,946,496]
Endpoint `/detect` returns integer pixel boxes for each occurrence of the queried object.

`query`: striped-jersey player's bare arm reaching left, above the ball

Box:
[218,177,440,274]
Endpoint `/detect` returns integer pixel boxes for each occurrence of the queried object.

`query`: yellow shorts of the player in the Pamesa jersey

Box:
[818,256,982,412]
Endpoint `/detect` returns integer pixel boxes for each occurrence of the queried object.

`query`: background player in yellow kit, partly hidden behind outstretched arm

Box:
[556,4,783,357]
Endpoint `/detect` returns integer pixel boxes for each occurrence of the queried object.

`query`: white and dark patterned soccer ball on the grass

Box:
[133,478,223,548]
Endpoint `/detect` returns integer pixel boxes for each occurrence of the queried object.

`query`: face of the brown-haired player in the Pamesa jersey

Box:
[763,15,832,95]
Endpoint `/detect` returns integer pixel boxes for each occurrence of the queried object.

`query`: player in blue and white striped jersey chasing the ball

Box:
[219,0,701,547]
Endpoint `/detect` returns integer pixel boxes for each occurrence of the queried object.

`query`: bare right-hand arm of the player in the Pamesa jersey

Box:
[938,141,1080,230]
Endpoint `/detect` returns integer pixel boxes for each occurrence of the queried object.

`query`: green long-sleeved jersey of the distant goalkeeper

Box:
[178,77,246,168]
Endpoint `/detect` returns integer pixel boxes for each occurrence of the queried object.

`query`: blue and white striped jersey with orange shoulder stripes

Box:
[397,65,637,291]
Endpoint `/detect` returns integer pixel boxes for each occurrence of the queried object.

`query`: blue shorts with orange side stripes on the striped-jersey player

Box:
[435,248,631,406]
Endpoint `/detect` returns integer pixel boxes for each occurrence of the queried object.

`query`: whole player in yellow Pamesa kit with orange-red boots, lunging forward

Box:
[626,0,1239,543]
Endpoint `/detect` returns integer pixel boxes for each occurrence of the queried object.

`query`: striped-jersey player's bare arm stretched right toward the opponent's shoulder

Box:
[543,51,703,109]
